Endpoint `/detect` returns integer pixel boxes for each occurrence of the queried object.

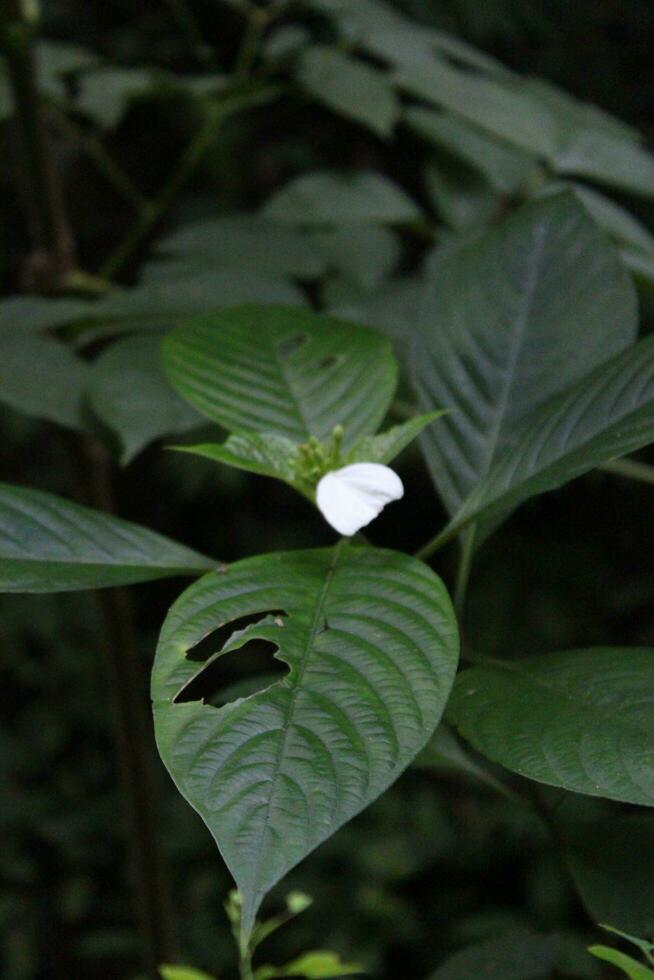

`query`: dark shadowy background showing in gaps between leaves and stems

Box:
[0,0,654,980]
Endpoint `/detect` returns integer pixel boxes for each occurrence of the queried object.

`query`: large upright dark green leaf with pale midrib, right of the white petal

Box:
[411,194,637,511]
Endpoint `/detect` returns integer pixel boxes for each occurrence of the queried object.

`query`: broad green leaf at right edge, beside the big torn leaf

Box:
[448,647,654,806]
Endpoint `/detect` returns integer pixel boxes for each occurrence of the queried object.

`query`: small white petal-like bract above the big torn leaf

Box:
[316,463,404,537]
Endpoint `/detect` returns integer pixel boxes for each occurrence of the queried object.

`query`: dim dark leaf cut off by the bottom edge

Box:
[430,929,558,980]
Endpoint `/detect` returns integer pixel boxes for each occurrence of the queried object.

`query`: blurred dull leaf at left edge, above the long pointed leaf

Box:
[0,331,89,429]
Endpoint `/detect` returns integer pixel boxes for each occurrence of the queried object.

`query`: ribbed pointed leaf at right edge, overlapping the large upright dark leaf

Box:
[443,337,654,538]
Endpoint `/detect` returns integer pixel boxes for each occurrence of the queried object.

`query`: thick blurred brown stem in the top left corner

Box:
[0,0,76,293]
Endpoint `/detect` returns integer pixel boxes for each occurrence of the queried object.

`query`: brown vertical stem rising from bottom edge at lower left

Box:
[77,439,175,980]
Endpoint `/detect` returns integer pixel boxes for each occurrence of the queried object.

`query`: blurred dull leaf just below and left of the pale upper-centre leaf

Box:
[150,214,325,282]
